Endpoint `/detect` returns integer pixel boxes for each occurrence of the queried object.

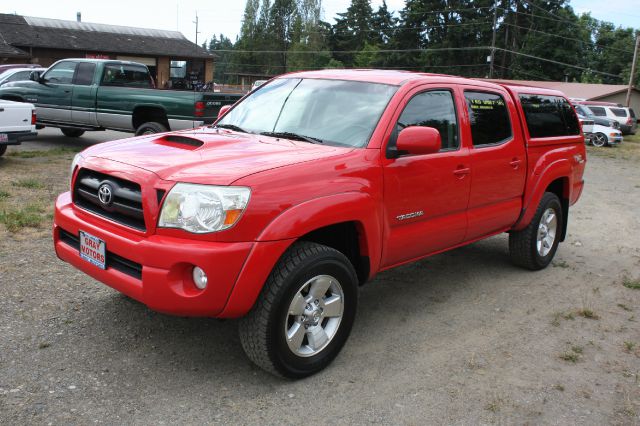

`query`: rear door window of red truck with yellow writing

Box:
[464,92,512,147]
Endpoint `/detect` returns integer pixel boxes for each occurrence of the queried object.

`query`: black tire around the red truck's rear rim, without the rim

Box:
[509,192,564,271]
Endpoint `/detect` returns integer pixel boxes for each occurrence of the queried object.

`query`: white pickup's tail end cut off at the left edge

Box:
[0,100,37,156]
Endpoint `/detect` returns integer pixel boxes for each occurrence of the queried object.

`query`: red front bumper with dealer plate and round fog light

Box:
[53,192,256,317]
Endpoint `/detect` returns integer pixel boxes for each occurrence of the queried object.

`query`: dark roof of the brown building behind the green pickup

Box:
[0,14,215,58]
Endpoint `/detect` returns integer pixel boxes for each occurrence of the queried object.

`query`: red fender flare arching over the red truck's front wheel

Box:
[219,192,382,318]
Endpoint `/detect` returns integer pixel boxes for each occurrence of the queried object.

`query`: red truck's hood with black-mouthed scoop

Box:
[82,128,353,185]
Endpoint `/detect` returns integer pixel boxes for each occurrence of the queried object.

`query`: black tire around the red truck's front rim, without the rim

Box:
[239,241,358,379]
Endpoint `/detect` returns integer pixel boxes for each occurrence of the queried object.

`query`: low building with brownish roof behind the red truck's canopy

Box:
[491,79,640,113]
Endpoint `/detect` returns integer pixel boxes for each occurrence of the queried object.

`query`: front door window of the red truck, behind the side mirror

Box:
[397,90,459,150]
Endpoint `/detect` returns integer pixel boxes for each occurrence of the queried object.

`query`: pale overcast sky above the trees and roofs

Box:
[0,0,640,44]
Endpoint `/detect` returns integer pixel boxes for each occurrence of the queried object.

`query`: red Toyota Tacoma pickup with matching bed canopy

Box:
[53,70,586,378]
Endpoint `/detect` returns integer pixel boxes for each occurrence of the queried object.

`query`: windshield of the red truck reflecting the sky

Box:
[217,78,397,147]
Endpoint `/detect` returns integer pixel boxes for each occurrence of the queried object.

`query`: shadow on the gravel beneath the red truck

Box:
[85,237,522,383]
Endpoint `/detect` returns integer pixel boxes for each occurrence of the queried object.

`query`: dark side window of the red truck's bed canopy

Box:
[520,95,580,138]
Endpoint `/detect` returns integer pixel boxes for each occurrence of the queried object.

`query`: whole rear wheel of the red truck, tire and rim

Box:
[509,192,564,271]
